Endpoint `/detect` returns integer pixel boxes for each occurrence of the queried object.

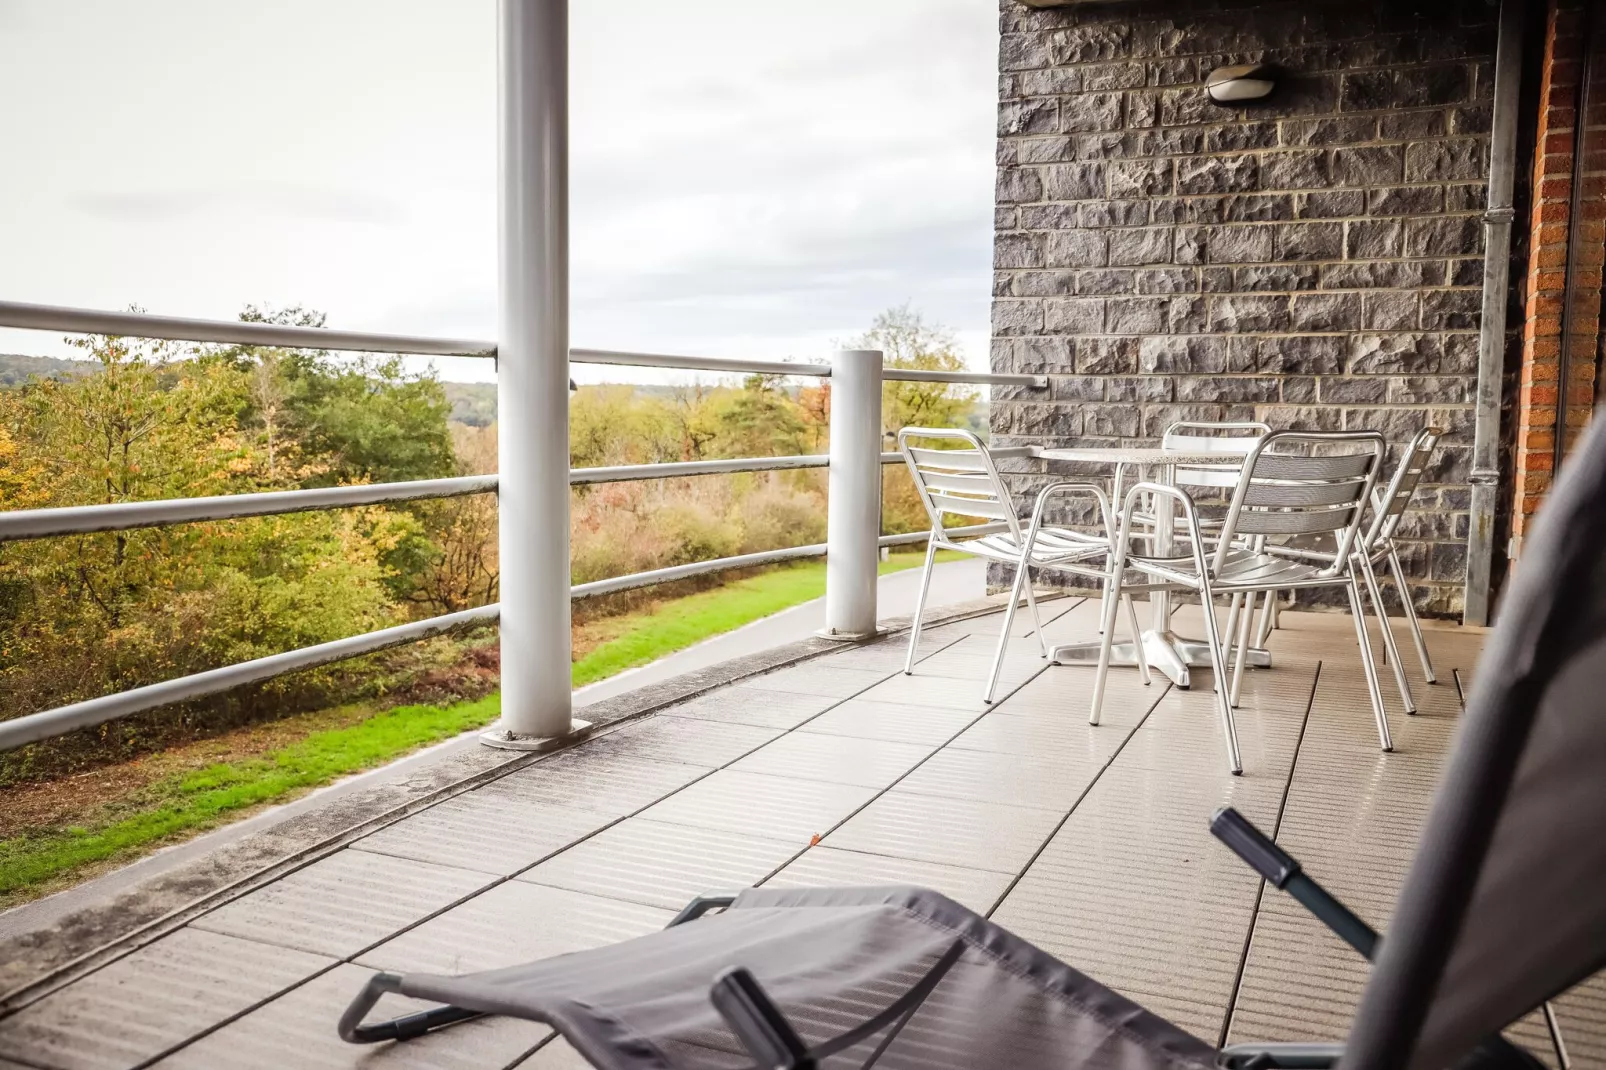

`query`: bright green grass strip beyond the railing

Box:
[0,553,960,908]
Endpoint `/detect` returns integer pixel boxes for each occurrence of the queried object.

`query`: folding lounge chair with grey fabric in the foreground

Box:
[340,421,1606,1070]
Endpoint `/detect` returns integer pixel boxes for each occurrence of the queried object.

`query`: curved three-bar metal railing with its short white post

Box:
[0,302,1047,750]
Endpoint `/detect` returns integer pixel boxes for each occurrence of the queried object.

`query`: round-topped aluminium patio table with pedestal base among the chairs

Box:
[1031,447,1272,688]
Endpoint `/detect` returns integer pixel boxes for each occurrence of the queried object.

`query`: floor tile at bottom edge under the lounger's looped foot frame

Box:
[156,964,551,1070]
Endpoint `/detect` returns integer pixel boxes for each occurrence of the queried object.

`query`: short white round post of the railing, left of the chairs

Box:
[821,349,882,639]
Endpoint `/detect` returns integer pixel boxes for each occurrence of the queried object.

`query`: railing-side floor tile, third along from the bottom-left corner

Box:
[352,790,612,877]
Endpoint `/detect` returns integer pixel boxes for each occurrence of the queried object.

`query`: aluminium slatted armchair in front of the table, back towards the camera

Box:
[1087,431,1394,774]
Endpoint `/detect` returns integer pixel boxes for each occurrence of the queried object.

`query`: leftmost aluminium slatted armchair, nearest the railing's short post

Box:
[898,427,1148,702]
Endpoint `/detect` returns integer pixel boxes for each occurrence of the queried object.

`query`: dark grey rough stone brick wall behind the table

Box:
[991,0,1495,615]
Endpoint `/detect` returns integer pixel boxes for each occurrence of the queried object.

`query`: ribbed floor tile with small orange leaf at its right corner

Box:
[519,818,798,911]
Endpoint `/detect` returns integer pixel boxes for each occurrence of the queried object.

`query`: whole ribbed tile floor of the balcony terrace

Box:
[0,598,1606,1070]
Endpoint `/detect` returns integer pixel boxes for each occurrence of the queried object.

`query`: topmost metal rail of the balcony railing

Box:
[0,300,1049,390]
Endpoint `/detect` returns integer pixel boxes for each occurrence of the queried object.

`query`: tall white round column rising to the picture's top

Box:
[483,0,577,749]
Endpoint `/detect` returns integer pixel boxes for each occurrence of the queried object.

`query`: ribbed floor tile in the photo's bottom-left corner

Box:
[0,929,334,1070]
